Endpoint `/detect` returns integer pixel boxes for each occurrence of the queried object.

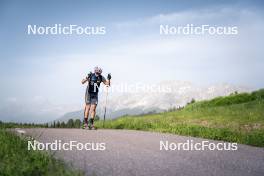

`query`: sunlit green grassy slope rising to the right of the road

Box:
[97,89,264,147]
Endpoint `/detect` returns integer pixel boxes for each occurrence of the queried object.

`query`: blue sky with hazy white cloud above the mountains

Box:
[0,0,264,122]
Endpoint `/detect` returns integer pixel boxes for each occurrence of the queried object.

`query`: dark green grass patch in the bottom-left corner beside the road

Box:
[0,128,82,176]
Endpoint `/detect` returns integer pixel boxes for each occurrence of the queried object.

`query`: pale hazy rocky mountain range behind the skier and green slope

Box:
[58,81,251,121]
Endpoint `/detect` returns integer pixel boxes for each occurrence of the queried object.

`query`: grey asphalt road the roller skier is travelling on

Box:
[21,129,264,176]
